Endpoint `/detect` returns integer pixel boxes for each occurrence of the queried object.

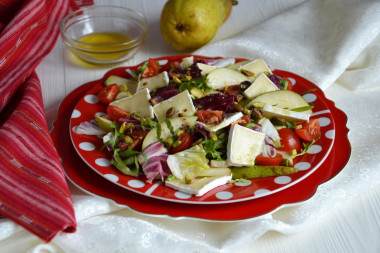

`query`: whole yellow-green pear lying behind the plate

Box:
[160,0,237,51]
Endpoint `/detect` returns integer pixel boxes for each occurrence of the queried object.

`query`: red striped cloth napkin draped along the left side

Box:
[0,0,88,242]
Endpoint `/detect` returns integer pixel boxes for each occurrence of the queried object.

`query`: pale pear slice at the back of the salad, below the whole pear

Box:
[207,68,249,90]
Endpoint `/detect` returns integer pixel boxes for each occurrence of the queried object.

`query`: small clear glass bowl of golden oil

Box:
[60,5,148,64]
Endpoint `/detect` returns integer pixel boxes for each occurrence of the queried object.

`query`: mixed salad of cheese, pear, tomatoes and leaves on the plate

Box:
[76,56,321,196]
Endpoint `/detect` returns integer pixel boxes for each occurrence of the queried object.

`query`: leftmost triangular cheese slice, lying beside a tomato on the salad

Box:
[110,88,154,118]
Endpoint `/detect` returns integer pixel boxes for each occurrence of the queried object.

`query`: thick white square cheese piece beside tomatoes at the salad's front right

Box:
[227,124,265,166]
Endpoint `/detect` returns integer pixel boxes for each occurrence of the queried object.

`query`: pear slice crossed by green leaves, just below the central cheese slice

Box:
[142,116,198,149]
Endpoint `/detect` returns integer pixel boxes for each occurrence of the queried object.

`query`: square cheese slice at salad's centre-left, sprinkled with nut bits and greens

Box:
[153,90,196,123]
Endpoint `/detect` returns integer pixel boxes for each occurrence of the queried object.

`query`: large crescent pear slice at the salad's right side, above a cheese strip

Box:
[246,90,312,114]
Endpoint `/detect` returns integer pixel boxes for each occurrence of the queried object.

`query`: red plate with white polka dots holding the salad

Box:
[70,56,335,204]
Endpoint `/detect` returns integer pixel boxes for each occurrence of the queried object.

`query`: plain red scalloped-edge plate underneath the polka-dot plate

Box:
[51,56,351,221]
